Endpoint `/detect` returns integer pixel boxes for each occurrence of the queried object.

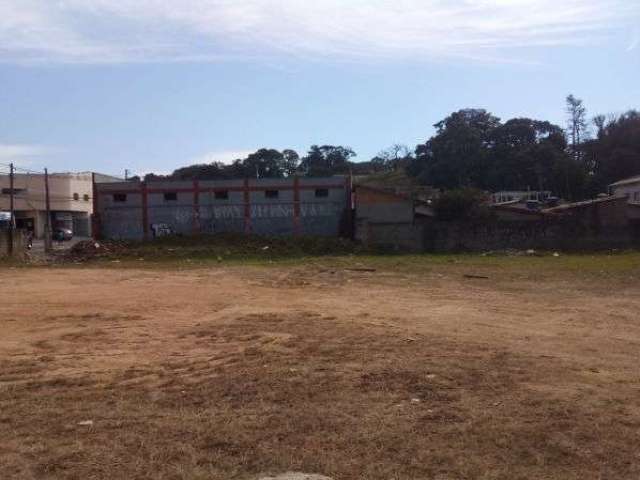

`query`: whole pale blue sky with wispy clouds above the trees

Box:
[0,0,640,175]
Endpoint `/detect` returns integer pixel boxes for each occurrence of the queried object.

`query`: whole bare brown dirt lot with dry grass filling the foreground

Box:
[0,257,640,480]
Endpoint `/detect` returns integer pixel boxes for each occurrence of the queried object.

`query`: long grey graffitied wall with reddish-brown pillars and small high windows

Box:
[96,177,349,239]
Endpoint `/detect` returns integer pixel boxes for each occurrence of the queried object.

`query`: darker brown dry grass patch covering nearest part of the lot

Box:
[0,312,640,480]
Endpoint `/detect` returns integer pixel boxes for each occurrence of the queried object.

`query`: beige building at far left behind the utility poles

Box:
[0,172,119,238]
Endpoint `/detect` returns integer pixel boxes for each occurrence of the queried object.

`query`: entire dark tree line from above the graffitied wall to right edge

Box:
[134,95,640,200]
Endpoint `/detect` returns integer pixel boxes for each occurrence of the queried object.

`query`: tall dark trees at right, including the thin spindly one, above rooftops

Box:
[408,95,640,200]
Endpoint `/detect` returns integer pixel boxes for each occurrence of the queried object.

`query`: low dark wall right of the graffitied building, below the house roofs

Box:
[356,187,640,252]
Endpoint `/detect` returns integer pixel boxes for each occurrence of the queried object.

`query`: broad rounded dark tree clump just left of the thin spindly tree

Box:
[408,110,587,199]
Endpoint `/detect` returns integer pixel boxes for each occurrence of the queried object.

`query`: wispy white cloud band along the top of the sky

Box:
[0,0,640,63]
